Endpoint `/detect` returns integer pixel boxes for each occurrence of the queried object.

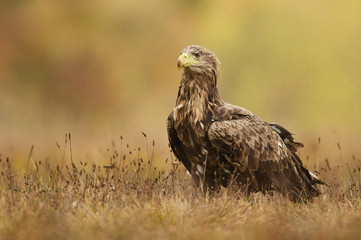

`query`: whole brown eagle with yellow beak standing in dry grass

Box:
[167,45,323,201]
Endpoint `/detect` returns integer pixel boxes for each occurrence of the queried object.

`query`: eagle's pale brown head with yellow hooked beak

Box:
[177,45,220,75]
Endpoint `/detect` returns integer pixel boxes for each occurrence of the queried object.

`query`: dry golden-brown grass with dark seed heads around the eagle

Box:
[0,134,361,240]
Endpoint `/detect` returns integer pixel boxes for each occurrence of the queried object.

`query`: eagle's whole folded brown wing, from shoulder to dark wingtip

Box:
[208,105,313,195]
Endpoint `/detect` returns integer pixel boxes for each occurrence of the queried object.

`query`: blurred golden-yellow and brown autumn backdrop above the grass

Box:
[0,0,361,167]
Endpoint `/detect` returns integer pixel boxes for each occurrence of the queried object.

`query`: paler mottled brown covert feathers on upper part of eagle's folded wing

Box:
[208,117,289,172]
